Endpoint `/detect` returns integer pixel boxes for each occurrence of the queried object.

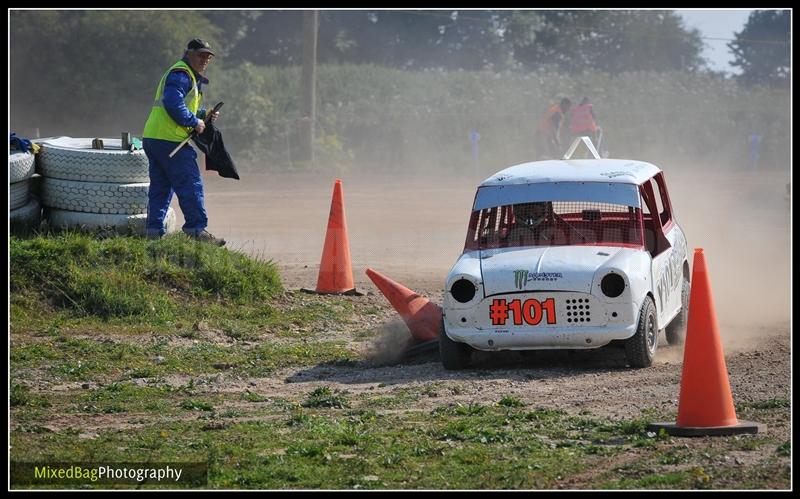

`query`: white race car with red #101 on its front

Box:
[439,138,690,369]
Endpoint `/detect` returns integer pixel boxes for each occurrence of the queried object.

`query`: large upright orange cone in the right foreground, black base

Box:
[650,248,761,437]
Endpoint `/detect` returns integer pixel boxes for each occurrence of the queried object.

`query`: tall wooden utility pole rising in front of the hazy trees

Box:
[299,10,319,164]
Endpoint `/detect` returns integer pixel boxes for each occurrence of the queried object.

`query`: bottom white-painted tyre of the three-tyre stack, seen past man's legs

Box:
[45,208,178,236]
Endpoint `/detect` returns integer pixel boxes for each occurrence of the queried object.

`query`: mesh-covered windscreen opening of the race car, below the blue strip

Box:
[464,200,643,251]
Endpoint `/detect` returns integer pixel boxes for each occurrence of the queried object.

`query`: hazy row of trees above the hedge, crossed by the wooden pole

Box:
[212,10,704,72]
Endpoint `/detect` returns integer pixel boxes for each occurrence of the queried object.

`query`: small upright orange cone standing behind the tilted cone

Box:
[315,180,360,294]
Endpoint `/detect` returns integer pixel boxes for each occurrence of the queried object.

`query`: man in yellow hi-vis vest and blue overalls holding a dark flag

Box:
[142,38,225,246]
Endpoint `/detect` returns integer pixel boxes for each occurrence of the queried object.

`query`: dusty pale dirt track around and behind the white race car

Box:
[177,168,791,418]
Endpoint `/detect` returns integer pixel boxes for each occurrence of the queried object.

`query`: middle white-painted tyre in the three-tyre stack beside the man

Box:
[42,177,150,215]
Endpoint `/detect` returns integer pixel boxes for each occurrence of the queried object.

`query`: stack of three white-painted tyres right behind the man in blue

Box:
[38,137,177,235]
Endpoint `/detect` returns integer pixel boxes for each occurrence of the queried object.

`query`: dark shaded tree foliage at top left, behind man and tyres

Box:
[9,10,220,133]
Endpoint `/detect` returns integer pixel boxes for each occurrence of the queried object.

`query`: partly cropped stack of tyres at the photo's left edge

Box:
[8,149,42,233]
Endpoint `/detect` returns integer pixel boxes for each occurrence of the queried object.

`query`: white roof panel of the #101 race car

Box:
[480,159,661,187]
